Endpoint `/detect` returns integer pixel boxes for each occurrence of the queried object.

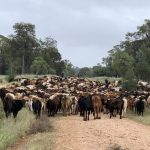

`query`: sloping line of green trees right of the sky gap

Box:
[80,20,150,81]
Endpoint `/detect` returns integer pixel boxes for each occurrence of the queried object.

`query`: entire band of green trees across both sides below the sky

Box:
[0,20,150,87]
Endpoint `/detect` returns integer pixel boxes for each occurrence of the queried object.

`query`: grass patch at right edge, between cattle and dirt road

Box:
[127,108,150,126]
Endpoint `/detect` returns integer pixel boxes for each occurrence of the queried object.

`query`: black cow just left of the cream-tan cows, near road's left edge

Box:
[46,99,57,117]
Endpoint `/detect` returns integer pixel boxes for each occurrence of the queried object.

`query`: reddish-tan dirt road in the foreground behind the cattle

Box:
[9,116,150,150]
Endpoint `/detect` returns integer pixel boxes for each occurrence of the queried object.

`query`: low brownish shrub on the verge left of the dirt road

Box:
[29,115,51,134]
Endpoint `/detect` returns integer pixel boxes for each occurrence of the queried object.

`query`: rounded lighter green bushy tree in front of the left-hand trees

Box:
[31,57,49,75]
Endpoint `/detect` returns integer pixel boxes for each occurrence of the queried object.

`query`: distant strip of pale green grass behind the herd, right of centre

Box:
[89,76,121,83]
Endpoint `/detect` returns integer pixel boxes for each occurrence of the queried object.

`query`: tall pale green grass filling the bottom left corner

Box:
[0,108,35,150]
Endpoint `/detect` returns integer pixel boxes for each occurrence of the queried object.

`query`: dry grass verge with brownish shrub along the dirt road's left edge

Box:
[8,116,55,150]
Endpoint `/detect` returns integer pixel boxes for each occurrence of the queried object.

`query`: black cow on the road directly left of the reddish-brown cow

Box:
[78,95,93,121]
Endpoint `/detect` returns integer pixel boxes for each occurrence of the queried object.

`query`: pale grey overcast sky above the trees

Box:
[0,0,150,67]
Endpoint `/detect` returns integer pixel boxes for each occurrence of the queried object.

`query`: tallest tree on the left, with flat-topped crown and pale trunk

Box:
[11,22,37,74]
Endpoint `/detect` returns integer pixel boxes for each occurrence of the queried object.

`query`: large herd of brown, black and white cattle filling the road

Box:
[0,76,150,121]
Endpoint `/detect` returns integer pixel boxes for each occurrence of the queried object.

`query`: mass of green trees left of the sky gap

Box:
[0,23,75,75]
